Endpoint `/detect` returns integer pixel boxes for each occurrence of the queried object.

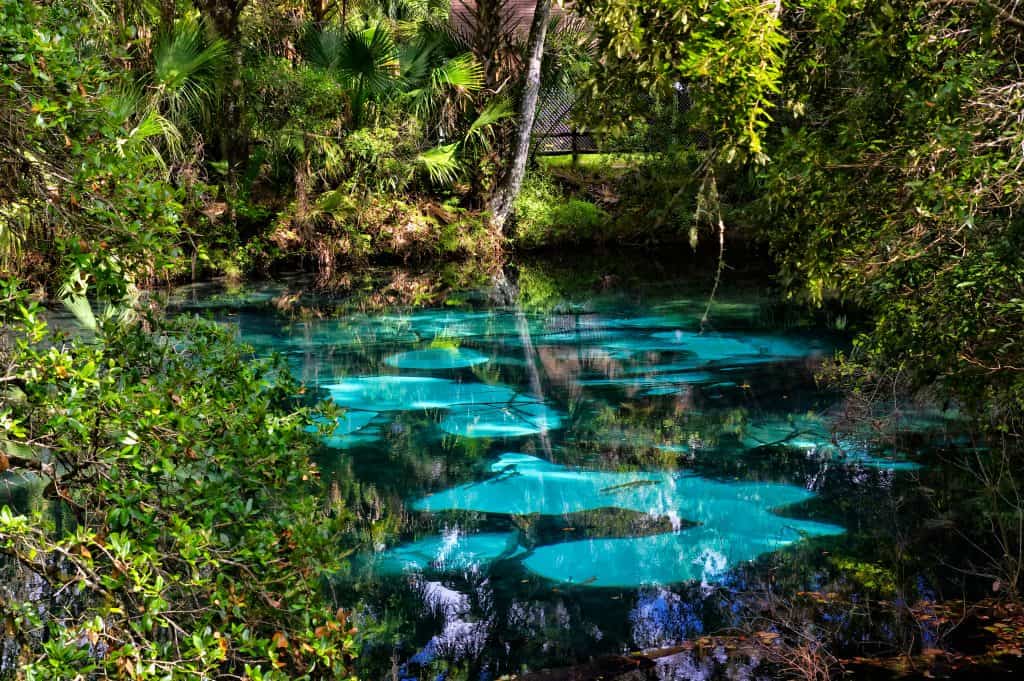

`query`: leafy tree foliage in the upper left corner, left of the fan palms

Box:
[0,0,185,293]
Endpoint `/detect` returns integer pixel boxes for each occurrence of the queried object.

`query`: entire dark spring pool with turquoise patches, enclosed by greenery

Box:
[172,256,1007,680]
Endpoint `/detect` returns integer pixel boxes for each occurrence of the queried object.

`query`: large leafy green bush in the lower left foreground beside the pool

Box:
[0,287,355,679]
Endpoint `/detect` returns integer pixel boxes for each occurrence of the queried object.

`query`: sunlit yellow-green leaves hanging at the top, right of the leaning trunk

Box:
[580,0,786,161]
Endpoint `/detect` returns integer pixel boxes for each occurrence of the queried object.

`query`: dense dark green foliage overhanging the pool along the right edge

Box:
[753,1,1024,432]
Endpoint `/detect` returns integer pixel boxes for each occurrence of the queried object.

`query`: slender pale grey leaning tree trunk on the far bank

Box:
[487,0,551,231]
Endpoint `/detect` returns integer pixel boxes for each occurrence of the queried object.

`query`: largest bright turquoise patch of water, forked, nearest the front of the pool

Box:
[413,454,844,587]
